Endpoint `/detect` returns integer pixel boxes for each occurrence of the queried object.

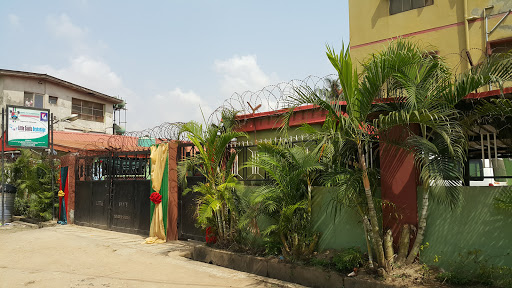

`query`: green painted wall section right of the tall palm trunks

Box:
[418,187,512,267]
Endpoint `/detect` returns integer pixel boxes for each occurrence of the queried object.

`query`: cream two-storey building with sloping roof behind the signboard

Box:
[0,69,124,134]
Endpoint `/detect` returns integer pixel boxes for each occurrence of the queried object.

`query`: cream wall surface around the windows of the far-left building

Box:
[0,76,113,134]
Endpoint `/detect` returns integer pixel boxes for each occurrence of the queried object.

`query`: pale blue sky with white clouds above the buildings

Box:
[0,0,349,131]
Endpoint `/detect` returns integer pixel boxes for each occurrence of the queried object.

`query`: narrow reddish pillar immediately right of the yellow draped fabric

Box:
[167,141,178,241]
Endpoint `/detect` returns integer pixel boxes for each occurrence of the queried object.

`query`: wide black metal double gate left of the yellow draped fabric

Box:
[75,151,151,235]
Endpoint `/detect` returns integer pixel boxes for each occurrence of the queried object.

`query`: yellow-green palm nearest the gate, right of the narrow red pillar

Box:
[178,113,247,242]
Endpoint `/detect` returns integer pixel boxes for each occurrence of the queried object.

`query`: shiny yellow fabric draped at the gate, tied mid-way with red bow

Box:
[145,143,169,244]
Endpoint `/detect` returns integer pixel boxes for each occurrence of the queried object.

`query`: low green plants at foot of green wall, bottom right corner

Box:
[436,249,512,287]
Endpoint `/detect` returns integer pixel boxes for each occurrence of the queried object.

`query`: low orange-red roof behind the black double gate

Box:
[53,131,156,152]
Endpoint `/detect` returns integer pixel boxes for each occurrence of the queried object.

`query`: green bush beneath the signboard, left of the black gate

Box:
[6,149,58,220]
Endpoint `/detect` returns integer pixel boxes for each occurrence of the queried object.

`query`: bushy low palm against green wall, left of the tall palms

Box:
[246,143,323,258]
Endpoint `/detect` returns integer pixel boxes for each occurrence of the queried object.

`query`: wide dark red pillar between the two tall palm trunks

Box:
[380,126,418,243]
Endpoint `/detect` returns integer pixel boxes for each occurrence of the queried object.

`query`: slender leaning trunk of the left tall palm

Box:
[357,142,388,270]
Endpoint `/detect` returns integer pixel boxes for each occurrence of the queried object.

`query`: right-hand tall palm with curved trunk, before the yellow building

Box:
[375,45,512,264]
